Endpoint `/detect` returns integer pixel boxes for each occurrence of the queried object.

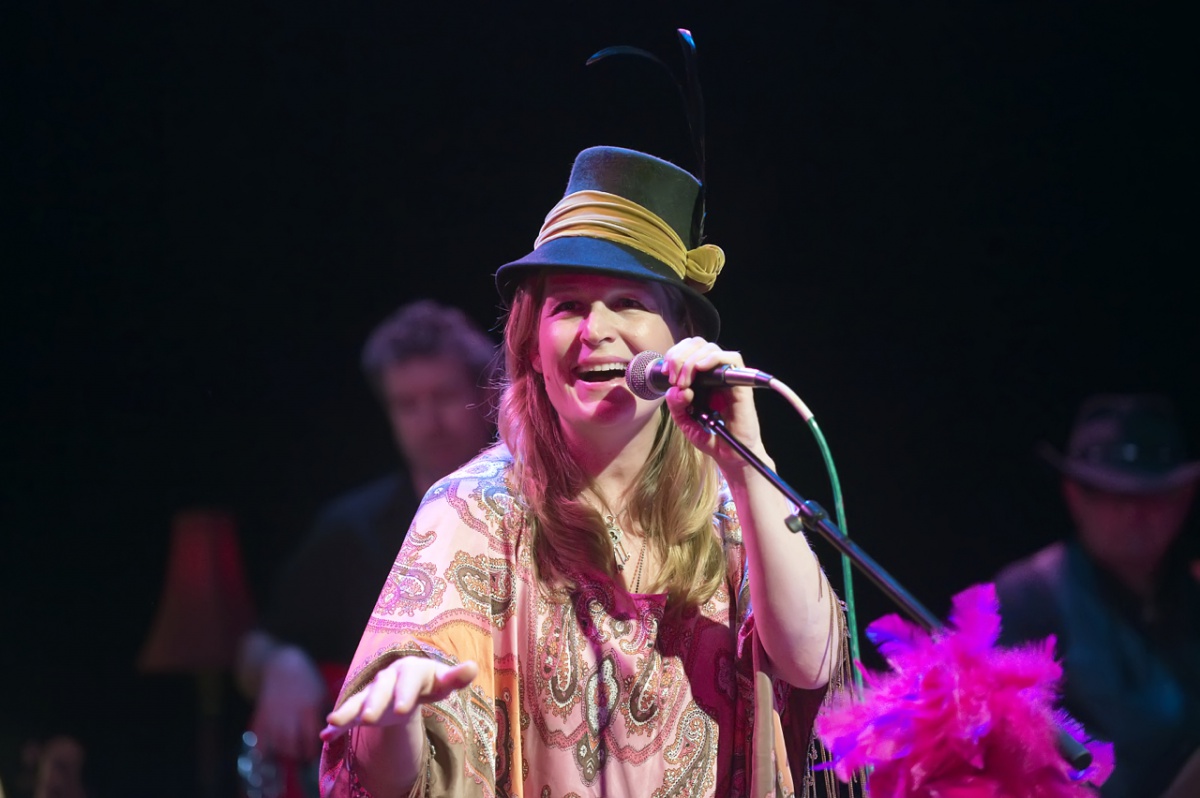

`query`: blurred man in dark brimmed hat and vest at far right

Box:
[996,395,1200,798]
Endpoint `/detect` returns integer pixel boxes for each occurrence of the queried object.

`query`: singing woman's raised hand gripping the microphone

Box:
[662,337,766,473]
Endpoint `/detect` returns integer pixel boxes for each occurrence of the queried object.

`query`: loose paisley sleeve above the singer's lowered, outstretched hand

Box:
[320,457,520,798]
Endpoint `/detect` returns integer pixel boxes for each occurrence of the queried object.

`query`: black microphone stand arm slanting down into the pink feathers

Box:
[689,400,1092,770]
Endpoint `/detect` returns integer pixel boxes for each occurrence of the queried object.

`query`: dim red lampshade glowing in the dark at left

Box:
[138,509,254,672]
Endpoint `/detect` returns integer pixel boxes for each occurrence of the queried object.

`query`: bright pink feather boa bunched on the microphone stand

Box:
[816,584,1112,798]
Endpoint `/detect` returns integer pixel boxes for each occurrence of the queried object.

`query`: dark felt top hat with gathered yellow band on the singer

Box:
[496,146,725,340]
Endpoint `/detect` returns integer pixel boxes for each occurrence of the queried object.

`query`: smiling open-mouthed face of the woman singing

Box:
[533,272,679,438]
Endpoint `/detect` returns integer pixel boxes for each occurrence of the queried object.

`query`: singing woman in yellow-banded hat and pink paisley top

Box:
[322,146,845,798]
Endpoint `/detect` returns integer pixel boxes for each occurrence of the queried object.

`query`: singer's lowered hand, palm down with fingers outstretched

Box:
[320,656,479,743]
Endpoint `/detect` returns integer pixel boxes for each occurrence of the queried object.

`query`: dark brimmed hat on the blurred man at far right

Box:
[1038,394,1200,493]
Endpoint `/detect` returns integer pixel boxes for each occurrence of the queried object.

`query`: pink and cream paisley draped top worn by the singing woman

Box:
[320,446,836,798]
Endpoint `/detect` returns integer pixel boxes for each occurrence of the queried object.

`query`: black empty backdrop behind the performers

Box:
[0,0,1200,796]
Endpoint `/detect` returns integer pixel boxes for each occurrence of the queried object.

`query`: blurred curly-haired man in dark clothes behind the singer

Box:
[238,300,497,796]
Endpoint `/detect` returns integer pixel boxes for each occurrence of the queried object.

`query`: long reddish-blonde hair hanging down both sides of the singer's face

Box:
[498,275,725,614]
